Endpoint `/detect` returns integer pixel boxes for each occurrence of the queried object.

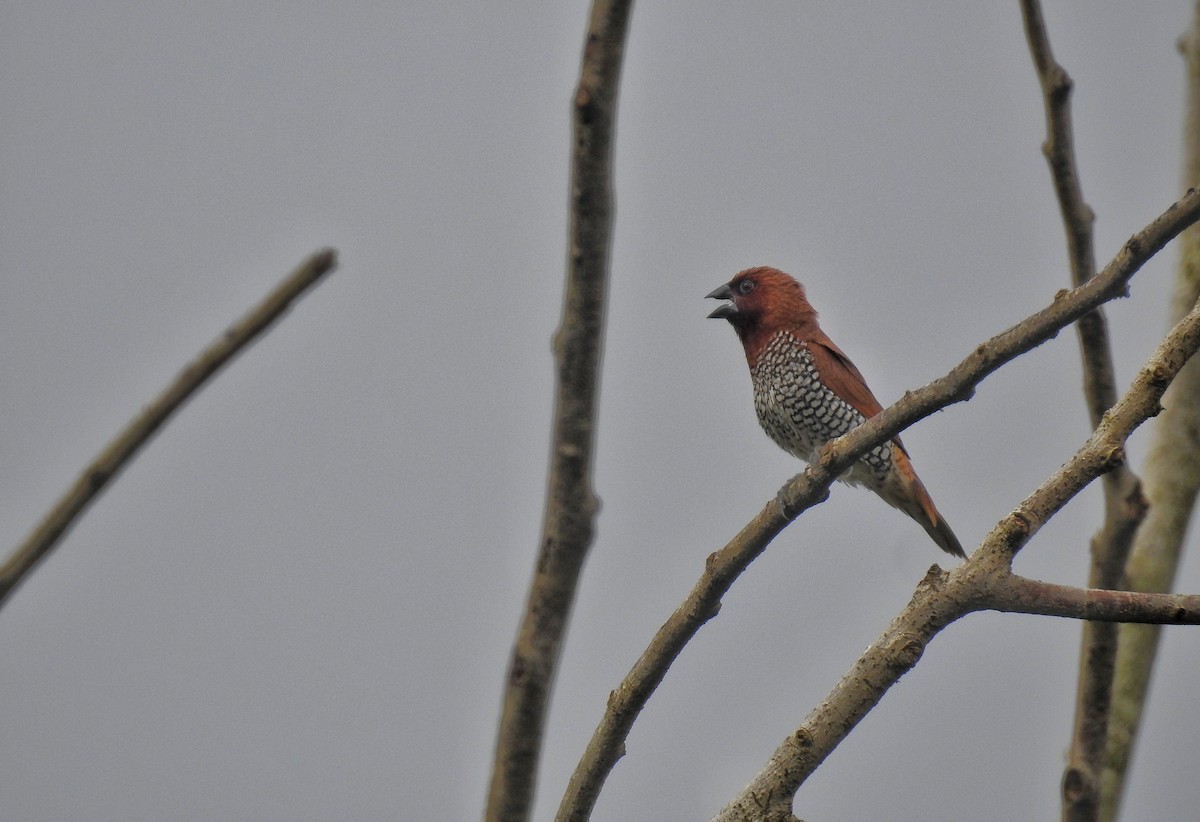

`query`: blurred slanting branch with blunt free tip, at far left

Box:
[0,248,337,606]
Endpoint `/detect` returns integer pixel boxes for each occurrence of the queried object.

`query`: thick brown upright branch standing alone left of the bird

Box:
[485,0,631,822]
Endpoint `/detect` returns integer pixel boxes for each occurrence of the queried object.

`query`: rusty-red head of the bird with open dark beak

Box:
[707,266,820,364]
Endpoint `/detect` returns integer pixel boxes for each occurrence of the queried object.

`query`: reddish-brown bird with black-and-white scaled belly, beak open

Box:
[706,266,966,557]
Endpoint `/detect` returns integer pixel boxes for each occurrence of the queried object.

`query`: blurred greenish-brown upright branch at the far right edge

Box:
[1099,2,1200,821]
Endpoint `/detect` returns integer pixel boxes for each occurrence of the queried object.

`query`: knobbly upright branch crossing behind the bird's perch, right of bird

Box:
[1021,0,1146,822]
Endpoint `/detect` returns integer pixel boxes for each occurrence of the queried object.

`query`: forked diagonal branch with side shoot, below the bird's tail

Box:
[714,288,1200,822]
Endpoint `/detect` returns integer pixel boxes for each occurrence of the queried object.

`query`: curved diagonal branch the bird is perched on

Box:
[556,191,1200,822]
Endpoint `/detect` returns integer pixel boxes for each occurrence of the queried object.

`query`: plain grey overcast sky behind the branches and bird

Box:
[0,0,1200,822]
